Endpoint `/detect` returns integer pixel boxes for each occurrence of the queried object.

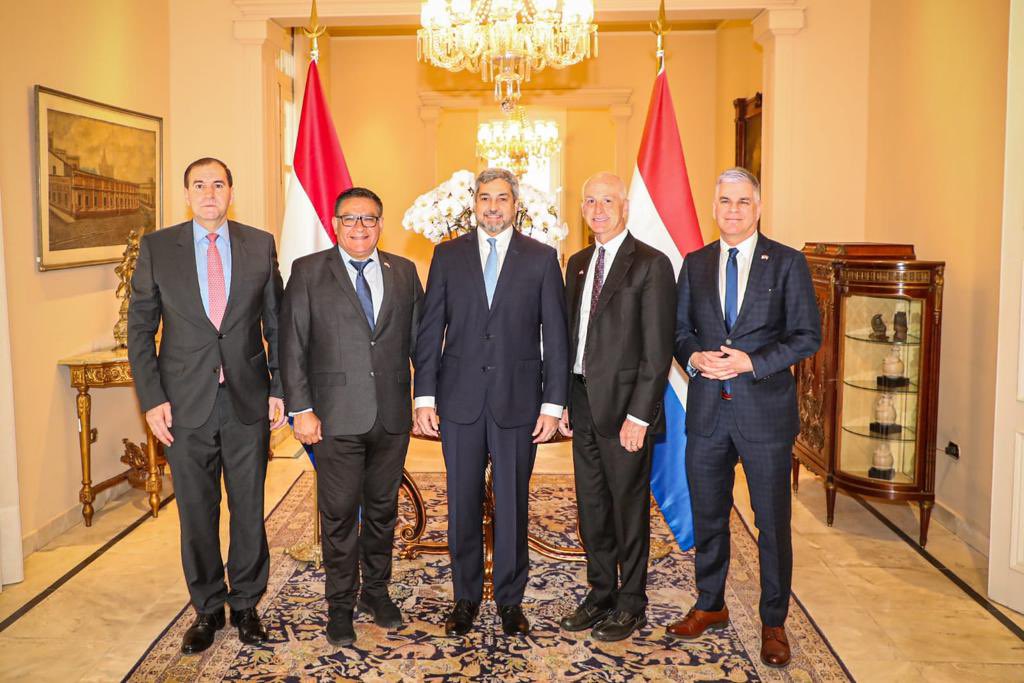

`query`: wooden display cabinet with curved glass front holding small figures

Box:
[793,242,945,546]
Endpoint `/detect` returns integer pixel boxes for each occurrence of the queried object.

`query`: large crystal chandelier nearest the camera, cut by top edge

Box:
[416,0,597,107]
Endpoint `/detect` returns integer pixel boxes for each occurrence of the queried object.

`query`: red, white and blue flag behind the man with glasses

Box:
[279,61,352,466]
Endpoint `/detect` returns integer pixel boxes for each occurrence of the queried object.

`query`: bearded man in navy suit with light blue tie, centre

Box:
[416,169,568,636]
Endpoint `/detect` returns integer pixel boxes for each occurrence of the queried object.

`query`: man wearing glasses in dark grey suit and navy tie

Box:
[281,187,423,646]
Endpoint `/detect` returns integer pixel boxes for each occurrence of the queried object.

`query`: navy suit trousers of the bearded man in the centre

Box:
[441,409,537,605]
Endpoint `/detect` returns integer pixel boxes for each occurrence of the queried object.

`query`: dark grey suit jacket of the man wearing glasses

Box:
[281,247,423,435]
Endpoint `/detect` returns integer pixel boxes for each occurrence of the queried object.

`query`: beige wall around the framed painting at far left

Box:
[0,0,170,550]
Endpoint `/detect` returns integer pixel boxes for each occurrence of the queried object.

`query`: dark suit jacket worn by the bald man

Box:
[565,234,676,438]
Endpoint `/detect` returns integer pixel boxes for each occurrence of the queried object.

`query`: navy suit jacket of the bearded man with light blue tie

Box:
[416,231,568,428]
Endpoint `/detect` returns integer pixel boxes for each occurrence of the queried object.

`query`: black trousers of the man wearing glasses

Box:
[313,417,409,612]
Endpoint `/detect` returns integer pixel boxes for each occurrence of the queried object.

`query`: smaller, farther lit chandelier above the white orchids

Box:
[476,106,561,176]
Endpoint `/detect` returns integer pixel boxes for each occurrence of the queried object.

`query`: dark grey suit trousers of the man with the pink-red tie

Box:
[164,386,270,613]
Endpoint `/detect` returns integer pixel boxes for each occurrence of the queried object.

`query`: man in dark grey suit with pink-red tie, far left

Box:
[128,158,287,654]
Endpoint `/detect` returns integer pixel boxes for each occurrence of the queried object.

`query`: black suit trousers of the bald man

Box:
[572,378,651,613]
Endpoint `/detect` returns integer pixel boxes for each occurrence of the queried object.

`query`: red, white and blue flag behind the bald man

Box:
[628,62,703,550]
